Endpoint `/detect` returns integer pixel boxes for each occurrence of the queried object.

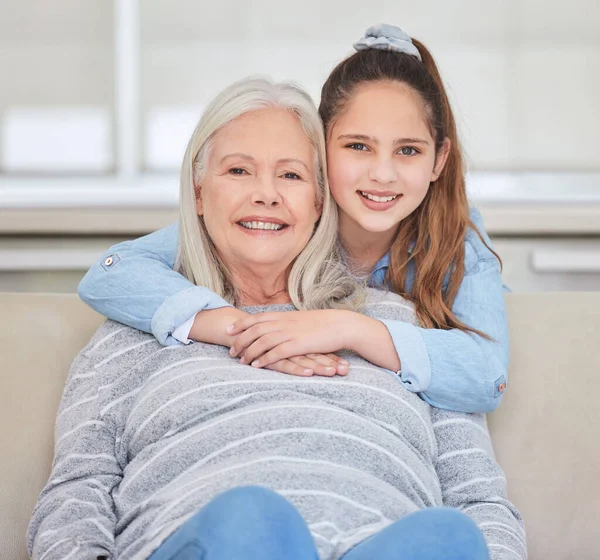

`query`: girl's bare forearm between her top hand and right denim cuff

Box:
[344,312,401,371]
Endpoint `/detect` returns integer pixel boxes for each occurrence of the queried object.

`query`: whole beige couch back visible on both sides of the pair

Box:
[0,293,600,560]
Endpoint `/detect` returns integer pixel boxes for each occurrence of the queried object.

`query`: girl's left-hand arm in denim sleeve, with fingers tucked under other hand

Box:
[79,224,348,375]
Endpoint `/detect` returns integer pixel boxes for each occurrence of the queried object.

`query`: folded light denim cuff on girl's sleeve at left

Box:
[152,286,233,346]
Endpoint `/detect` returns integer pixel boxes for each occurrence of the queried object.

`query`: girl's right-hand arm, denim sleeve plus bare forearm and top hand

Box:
[227,211,509,412]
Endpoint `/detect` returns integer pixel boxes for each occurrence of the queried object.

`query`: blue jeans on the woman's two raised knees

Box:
[150,486,489,560]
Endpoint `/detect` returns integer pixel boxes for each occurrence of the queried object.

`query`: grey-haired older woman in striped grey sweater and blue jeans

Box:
[28,79,526,560]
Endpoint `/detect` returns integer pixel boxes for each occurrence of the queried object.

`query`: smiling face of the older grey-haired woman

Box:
[196,109,320,272]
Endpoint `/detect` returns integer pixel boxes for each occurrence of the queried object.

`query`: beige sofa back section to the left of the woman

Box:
[0,294,103,560]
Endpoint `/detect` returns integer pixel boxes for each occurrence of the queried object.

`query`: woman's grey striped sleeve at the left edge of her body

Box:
[27,354,122,560]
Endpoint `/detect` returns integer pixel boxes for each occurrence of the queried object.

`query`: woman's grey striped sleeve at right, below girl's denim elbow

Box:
[431,408,527,560]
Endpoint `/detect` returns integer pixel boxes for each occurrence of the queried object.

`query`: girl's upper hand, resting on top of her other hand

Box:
[227,309,355,371]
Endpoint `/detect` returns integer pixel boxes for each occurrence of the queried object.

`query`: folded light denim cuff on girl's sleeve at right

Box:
[381,319,431,393]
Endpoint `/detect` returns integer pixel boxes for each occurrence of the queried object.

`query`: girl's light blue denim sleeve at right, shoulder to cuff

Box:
[383,210,509,412]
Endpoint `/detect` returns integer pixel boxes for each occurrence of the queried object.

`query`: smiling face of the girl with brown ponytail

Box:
[327,82,449,235]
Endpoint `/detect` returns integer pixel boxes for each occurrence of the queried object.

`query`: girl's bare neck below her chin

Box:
[340,213,399,274]
